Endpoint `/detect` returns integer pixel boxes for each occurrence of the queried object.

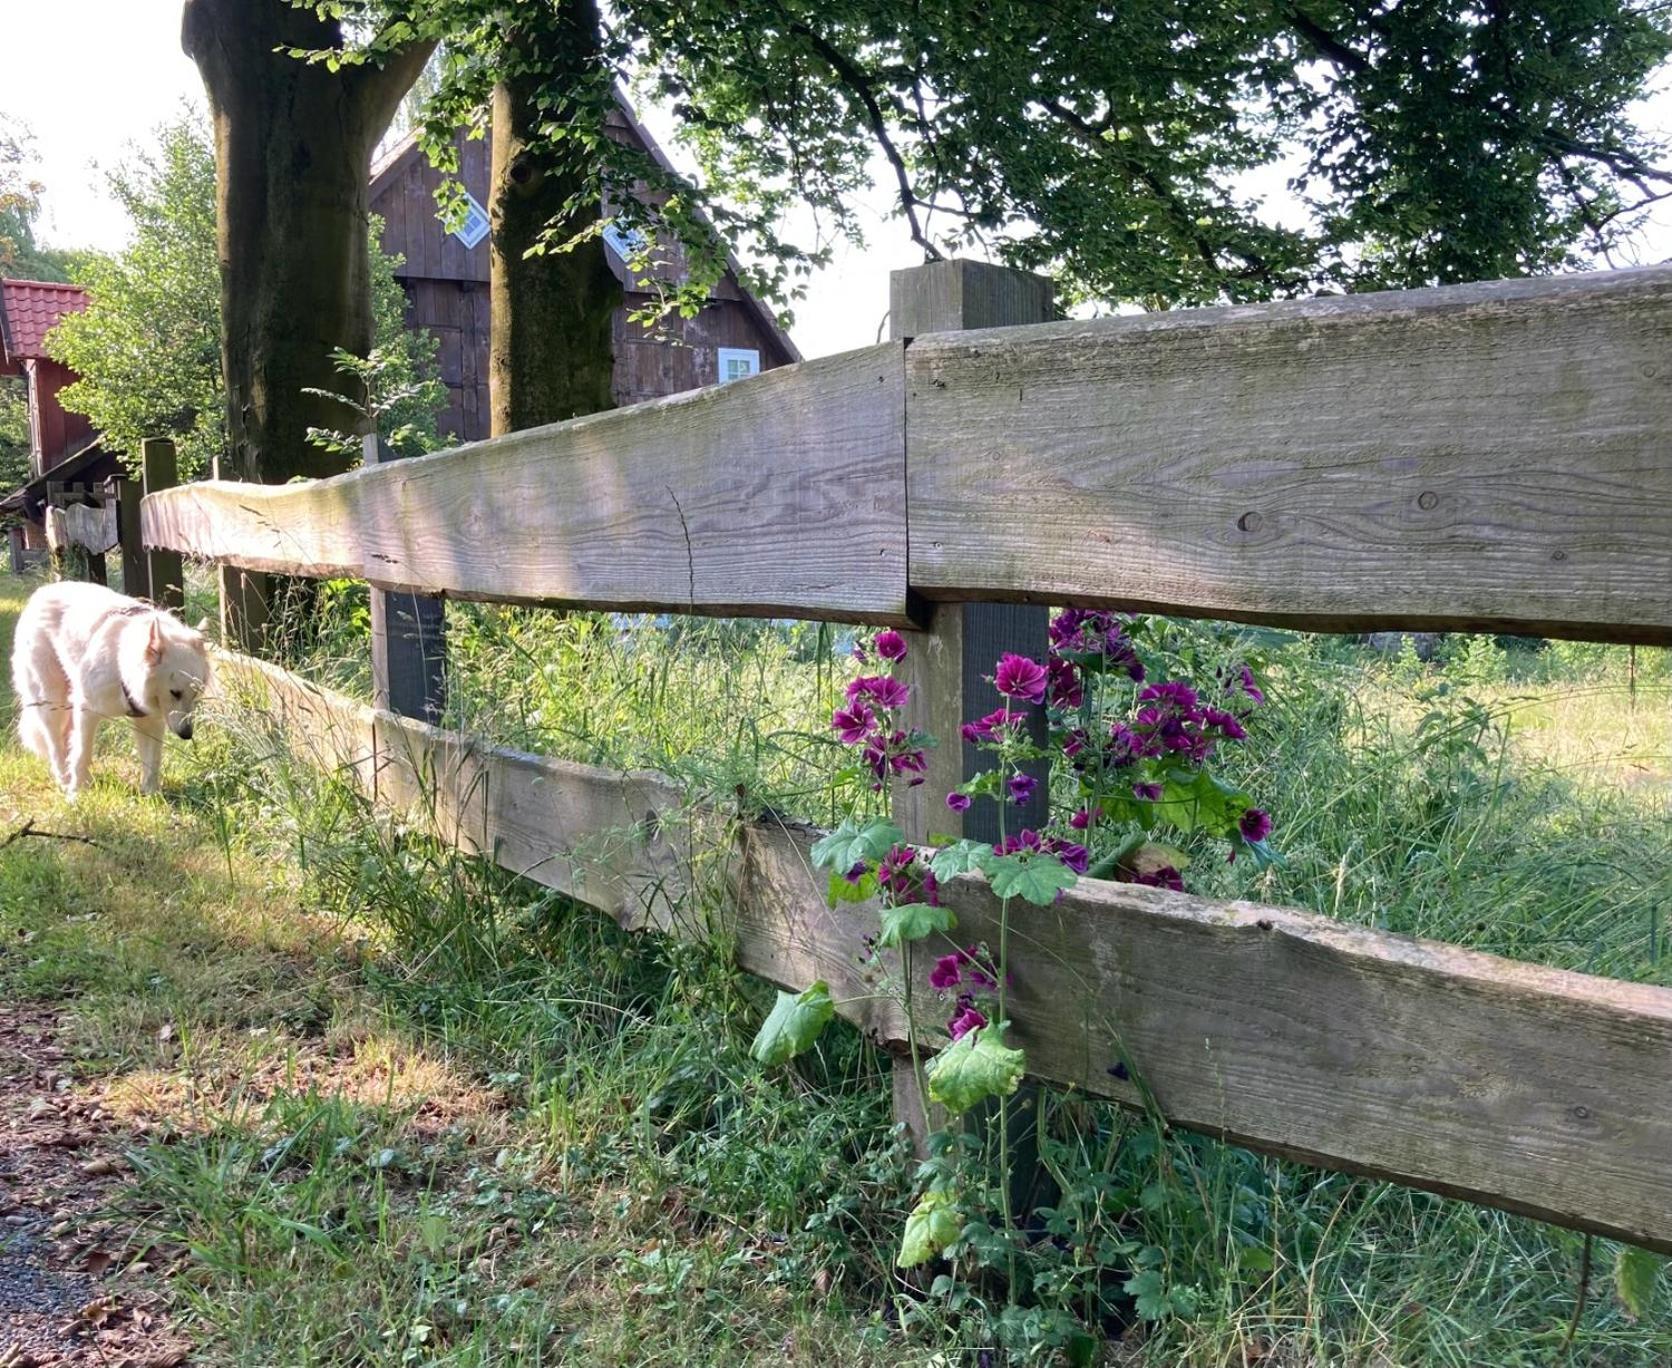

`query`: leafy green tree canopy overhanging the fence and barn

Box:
[314,0,1672,306]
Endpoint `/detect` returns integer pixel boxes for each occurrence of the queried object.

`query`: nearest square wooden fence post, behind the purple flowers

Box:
[888,261,1052,1170]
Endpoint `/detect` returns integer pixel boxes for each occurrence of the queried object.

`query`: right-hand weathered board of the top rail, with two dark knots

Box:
[906,268,1672,642]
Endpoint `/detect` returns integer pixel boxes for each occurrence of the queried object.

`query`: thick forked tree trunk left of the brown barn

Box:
[181,0,431,483]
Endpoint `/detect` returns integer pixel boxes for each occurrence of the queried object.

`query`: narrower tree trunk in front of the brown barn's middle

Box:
[488,0,622,436]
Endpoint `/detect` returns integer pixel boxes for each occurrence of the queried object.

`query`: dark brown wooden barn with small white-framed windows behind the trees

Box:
[371,105,801,442]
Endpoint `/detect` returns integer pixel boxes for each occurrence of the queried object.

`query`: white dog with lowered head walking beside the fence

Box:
[12,582,209,803]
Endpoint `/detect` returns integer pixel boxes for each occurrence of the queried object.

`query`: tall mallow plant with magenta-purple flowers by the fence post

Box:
[754,609,1277,1296]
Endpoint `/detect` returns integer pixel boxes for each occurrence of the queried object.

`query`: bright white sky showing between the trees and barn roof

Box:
[0,0,1672,356]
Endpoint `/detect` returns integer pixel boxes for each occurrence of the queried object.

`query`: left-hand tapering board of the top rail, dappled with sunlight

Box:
[144,345,906,622]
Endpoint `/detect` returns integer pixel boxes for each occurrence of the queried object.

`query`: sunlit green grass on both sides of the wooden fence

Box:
[0,558,1672,1368]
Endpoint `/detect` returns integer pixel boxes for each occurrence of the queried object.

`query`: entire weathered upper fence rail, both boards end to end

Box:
[142,268,1672,642]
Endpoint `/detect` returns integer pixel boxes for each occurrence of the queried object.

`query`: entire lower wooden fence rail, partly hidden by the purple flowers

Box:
[217,656,1672,1253]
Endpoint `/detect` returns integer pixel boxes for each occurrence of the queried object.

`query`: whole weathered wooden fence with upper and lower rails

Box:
[123,263,1672,1253]
